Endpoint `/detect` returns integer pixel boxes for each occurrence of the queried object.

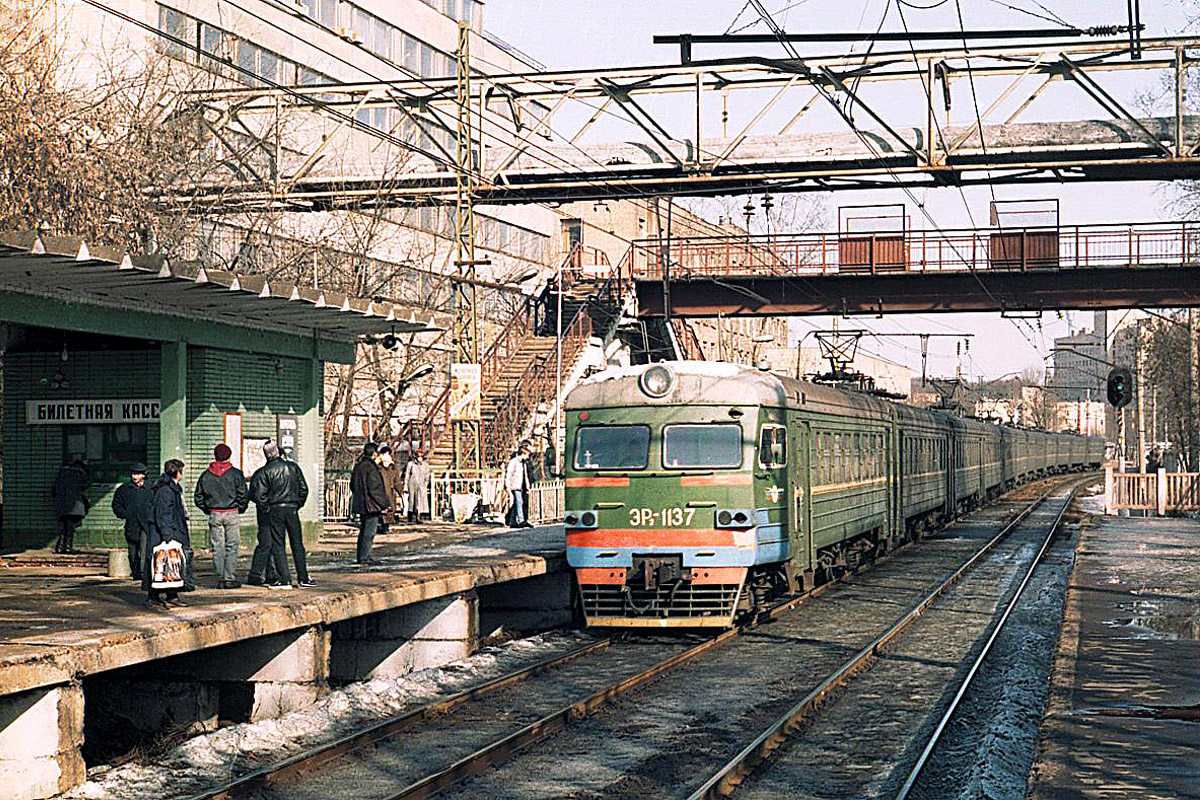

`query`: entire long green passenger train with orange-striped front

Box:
[565,361,1104,627]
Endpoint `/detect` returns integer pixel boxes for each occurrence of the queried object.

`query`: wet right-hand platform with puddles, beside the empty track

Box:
[1028,517,1200,800]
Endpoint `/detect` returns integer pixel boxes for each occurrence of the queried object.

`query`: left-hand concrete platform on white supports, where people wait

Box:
[0,527,571,798]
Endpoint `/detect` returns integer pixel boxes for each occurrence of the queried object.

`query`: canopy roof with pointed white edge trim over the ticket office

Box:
[0,231,444,344]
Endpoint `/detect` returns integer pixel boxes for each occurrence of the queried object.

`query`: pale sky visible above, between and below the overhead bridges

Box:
[485,0,1187,377]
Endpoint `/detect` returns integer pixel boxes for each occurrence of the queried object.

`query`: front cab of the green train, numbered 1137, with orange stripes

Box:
[564,367,793,627]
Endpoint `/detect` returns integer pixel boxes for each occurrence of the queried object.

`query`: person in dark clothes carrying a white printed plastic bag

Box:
[142,458,191,610]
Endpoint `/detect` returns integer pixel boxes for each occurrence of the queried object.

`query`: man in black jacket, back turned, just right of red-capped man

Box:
[250,441,316,589]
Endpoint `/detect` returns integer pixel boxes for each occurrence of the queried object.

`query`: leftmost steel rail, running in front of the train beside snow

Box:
[188,638,612,800]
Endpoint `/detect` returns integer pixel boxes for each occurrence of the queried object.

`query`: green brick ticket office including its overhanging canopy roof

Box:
[0,233,437,553]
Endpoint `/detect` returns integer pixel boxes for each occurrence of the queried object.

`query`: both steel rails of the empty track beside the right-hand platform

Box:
[689,481,1081,800]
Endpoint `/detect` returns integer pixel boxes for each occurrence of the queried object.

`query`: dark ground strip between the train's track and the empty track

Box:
[429,489,1060,799]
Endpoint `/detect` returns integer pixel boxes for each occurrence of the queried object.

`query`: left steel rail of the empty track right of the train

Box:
[689,482,1074,800]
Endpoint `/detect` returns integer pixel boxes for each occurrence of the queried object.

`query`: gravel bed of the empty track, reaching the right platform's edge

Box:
[734,489,1072,800]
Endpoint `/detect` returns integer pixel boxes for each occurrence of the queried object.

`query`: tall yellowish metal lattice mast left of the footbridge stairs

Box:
[454,22,482,470]
